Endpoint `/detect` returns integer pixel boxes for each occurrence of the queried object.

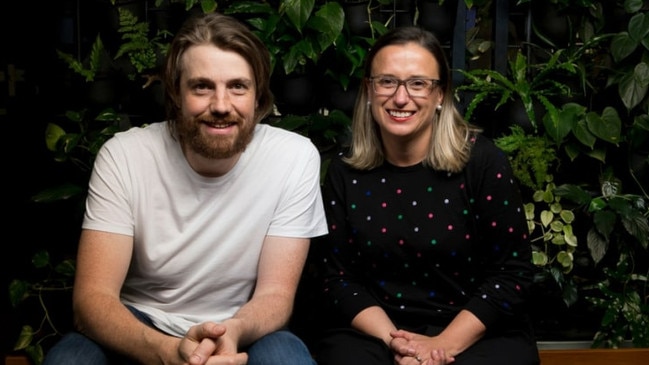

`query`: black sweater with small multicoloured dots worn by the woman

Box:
[314,136,534,328]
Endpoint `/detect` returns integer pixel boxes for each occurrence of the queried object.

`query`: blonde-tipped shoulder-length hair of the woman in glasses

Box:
[345,26,481,172]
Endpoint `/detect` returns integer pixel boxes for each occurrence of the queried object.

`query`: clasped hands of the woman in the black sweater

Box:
[390,330,455,365]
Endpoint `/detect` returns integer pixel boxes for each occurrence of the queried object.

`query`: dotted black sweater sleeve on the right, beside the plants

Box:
[465,137,534,328]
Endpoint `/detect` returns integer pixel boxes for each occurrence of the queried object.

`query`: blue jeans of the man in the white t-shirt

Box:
[43,307,315,365]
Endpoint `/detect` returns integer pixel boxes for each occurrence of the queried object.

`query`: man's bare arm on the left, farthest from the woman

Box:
[73,230,182,364]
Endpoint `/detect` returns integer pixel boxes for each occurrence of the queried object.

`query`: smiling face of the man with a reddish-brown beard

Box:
[178,45,256,159]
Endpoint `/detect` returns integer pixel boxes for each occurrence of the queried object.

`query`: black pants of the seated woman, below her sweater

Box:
[315,327,540,365]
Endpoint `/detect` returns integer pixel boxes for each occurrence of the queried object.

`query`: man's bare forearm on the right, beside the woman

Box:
[224,236,309,348]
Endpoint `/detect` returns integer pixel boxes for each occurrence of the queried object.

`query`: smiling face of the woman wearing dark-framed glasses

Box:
[367,43,443,143]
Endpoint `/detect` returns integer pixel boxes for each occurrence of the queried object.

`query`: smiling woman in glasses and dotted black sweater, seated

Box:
[312,27,539,365]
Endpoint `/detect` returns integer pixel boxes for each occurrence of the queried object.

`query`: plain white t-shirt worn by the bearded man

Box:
[83,122,327,336]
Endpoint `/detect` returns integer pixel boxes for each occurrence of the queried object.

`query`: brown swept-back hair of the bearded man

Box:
[163,12,273,125]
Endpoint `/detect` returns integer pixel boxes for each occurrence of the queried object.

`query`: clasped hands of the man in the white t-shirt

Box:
[178,322,248,365]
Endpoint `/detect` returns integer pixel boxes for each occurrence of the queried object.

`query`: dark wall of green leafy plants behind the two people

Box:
[10,0,649,363]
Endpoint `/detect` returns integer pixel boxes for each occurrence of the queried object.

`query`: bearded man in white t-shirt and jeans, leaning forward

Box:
[45,13,326,365]
